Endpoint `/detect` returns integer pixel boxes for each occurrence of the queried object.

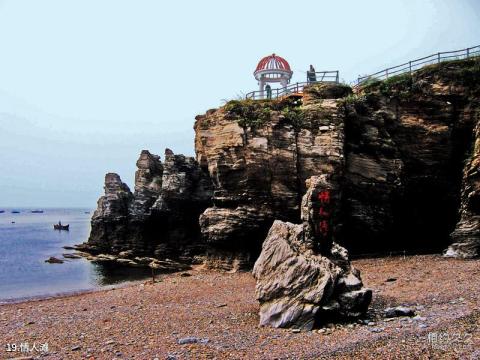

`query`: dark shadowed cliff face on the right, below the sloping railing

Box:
[342,60,480,253]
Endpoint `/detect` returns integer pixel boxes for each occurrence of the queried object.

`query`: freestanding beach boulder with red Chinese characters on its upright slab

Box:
[253,175,372,330]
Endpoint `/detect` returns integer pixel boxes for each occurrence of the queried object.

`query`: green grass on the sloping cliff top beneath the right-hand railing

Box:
[362,56,480,98]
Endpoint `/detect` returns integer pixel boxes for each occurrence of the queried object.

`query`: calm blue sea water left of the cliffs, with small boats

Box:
[0,208,149,303]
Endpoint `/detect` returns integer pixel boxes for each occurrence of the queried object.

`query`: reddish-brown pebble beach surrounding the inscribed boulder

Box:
[0,255,480,360]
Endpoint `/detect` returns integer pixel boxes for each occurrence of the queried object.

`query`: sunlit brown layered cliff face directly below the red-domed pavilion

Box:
[195,86,351,266]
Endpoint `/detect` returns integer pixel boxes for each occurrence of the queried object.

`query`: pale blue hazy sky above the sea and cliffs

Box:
[0,0,480,208]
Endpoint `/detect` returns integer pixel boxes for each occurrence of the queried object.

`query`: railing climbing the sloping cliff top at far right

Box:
[355,45,480,87]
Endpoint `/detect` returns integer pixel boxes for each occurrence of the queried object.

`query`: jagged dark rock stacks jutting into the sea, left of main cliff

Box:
[82,149,212,261]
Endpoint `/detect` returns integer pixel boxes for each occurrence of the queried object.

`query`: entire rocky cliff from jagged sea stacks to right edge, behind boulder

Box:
[81,56,480,269]
